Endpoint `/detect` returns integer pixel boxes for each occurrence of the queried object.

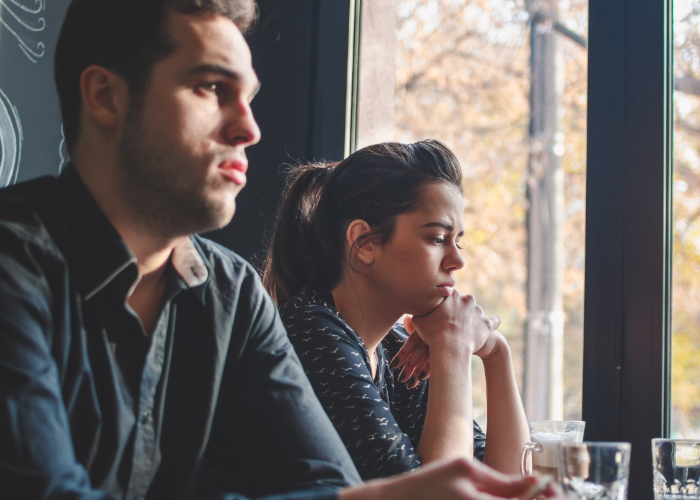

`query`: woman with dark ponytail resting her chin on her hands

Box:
[263,141,528,480]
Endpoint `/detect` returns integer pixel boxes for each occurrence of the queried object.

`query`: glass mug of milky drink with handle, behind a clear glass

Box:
[520,420,586,481]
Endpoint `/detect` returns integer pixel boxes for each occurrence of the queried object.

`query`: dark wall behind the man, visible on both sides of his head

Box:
[0,0,350,261]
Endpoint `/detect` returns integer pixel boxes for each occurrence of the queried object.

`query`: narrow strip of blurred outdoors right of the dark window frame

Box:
[671,0,700,438]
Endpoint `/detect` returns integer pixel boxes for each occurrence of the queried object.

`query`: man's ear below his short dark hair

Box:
[80,65,129,129]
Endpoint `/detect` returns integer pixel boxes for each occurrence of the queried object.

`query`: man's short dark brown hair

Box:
[54,0,257,153]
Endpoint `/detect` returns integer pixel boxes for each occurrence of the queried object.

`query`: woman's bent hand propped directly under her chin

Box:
[412,290,501,354]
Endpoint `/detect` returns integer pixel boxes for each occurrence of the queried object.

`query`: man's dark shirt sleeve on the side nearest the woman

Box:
[200,272,360,500]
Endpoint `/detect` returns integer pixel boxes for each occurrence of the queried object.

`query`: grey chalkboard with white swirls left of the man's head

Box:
[0,0,69,186]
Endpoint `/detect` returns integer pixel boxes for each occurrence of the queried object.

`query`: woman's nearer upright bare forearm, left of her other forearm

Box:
[418,346,474,463]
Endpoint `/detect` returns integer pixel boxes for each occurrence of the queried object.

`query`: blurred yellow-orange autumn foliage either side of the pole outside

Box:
[395,0,587,418]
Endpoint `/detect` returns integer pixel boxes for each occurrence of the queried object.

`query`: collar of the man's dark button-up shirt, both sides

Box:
[57,164,210,302]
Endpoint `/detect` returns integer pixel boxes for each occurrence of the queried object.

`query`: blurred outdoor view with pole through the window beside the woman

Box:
[357,0,588,424]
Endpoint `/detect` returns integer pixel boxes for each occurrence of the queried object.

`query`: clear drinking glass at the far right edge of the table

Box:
[651,439,700,500]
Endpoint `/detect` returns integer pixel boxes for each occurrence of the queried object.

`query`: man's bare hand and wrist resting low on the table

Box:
[339,459,564,500]
